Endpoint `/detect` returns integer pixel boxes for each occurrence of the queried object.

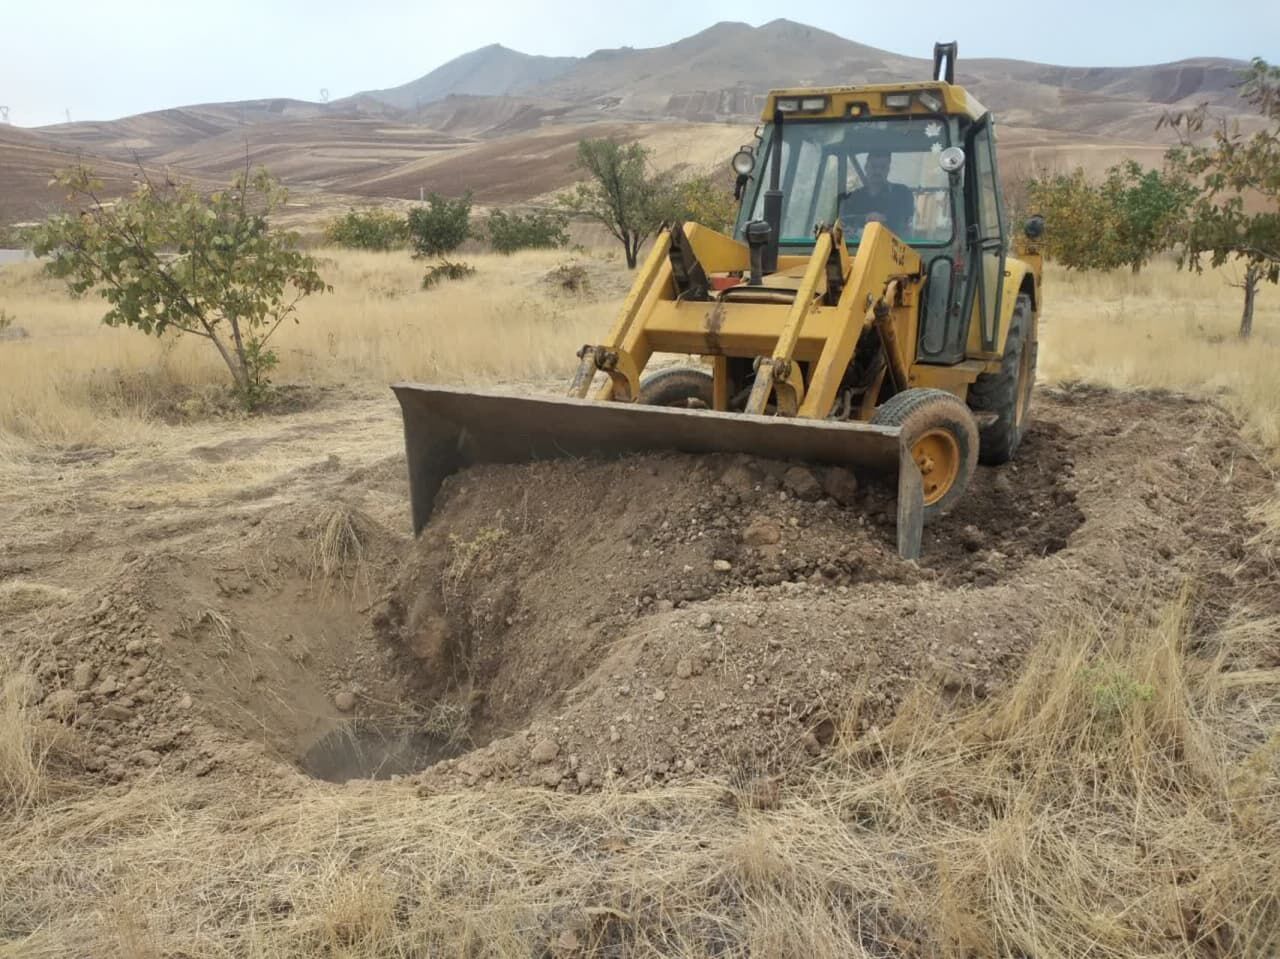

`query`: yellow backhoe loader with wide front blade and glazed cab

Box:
[394,44,1043,558]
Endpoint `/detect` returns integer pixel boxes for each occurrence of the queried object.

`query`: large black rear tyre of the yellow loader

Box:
[969,293,1038,466]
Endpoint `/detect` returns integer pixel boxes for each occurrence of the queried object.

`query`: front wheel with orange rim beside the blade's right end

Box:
[872,389,978,522]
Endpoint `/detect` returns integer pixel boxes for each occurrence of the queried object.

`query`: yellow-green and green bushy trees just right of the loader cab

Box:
[1027,160,1196,273]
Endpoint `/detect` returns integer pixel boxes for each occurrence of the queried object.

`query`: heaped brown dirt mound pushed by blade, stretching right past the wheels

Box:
[375,391,1266,789]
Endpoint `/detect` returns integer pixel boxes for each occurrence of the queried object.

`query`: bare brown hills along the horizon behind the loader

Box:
[0,19,1254,219]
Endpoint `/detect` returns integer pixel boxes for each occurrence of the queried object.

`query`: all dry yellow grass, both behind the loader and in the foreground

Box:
[0,251,1280,959]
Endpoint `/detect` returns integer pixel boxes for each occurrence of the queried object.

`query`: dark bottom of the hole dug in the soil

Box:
[300,720,467,782]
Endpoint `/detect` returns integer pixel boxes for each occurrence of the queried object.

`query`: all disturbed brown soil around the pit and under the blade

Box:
[0,388,1275,791]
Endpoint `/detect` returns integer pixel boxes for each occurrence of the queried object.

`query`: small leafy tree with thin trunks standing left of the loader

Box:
[32,166,330,408]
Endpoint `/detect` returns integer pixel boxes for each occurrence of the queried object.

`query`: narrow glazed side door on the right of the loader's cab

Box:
[965,113,1005,353]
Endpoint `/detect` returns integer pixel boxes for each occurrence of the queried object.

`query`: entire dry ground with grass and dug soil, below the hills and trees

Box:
[0,251,1280,959]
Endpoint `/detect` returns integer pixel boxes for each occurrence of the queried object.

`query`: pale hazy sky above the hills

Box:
[0,0,1280,125]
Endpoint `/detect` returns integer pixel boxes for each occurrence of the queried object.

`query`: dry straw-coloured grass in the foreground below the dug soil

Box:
[0,594,1280,959]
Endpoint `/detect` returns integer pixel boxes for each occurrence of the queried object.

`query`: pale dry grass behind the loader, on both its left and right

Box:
[0,250,1280,447]
